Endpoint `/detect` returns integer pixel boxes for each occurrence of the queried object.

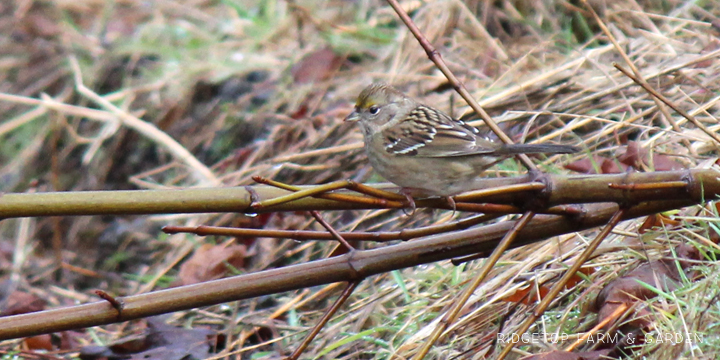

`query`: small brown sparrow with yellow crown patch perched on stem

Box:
[345,84,579,196]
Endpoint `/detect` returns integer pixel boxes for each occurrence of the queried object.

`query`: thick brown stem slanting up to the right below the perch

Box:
[0,198,704,340]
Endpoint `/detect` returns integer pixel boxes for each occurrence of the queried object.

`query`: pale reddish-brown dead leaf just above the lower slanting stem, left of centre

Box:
[174,244,247,286]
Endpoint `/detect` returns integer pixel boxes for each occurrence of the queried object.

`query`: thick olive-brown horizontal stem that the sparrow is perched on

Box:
[0,169,720,219]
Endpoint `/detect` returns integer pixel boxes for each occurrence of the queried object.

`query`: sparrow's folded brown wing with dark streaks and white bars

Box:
[382,105,495,157]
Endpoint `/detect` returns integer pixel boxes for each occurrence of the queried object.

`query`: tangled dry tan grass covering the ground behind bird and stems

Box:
[0,0,720,359]
